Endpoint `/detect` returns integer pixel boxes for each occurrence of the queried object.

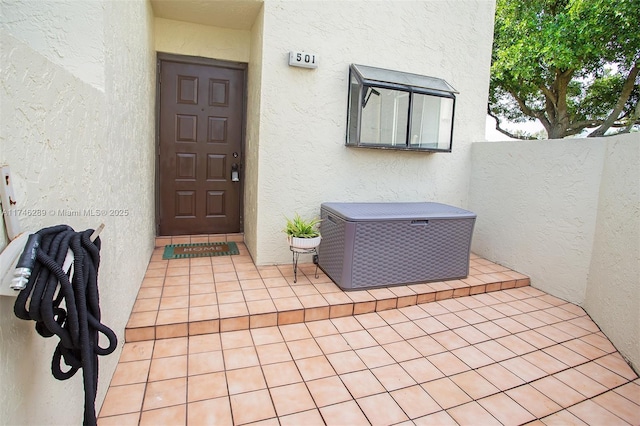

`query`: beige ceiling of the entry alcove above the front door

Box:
[150,0,264,30]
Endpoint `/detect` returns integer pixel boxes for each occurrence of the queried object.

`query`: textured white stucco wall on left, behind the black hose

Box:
[0,0,155,425]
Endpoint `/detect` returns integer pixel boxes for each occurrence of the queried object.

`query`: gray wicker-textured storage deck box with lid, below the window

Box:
[318,203,476,290]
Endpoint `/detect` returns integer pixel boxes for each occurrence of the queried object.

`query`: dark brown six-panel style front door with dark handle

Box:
[158,56,245,235]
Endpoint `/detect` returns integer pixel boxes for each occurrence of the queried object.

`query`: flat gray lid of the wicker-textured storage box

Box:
[321,203,476,221]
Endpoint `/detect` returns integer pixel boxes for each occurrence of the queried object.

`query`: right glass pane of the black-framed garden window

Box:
[409,93,453,150]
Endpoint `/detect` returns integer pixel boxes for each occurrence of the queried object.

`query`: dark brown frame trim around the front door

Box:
[154,52,249,237]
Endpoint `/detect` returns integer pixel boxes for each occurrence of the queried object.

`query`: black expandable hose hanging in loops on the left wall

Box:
[14,225,118,425]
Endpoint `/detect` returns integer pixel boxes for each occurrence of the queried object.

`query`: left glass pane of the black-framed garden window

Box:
[360,87,409,147]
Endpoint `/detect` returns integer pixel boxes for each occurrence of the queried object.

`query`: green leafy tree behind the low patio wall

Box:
[488,0,640,139]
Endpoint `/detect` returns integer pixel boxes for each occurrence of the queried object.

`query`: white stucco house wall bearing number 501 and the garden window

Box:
[249,0,494,264]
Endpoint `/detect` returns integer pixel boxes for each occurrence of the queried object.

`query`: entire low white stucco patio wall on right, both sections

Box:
[469,133,640,369]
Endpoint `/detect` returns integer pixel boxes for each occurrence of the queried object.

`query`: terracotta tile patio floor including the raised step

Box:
[98,236,640,425]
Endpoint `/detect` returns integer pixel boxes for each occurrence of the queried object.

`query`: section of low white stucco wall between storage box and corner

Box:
[469,139,605,304]
